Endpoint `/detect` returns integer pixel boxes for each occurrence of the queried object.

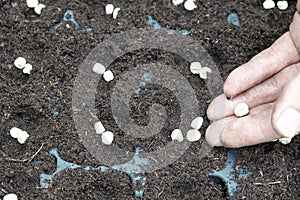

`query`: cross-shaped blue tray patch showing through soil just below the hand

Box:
[209,149,253,199]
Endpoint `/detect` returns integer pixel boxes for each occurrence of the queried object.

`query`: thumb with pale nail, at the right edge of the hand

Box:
[272,69,300,138]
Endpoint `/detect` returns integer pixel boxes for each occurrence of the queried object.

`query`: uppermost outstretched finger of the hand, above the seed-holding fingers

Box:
[224,32,300,97]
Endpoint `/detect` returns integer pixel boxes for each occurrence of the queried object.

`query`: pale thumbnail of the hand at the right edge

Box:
[275,108,300,138]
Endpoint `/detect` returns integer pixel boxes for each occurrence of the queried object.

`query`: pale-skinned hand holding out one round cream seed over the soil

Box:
[206,1,300,148]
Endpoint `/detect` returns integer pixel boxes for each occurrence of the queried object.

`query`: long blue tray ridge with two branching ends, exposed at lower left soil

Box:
[40,148,149,198]
